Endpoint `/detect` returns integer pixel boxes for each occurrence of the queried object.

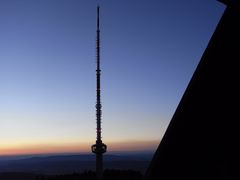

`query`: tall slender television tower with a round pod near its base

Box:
[91,6,107,179]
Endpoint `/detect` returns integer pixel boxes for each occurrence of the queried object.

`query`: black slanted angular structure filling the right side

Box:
[145,0,240,180]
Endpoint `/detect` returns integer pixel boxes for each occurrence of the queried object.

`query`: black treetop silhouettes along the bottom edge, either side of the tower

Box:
[0,169,143,180]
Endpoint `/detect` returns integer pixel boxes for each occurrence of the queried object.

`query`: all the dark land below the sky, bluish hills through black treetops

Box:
[0,153,152,180]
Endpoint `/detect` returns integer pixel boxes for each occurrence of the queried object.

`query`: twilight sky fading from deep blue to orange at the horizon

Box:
[0,0,225,155]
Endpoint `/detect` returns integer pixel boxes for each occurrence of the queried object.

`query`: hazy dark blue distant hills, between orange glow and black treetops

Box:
[0,154,152,174]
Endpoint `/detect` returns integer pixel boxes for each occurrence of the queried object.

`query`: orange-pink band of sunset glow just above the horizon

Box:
[0,141,159,156]
